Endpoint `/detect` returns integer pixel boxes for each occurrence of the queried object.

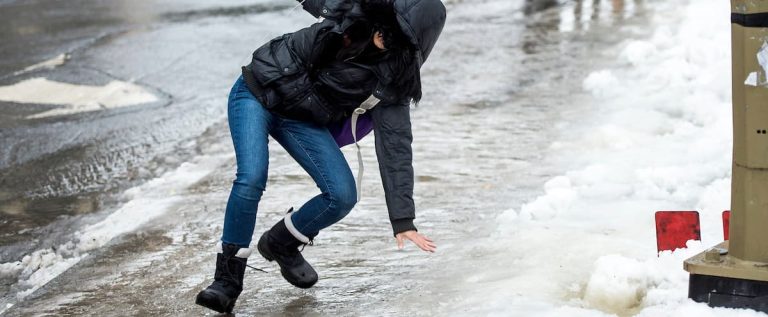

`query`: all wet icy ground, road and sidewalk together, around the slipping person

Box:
[0,0,651,316]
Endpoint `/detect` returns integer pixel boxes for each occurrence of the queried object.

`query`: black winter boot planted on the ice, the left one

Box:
[195,243,251,313]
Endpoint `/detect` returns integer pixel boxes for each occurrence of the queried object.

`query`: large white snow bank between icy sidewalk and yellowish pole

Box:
[492,0,765,316]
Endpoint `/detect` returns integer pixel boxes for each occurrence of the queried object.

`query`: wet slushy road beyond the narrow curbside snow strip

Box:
[0,1,312,252]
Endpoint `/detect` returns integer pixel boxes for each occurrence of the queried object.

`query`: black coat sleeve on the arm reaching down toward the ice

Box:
[372,104,416,235]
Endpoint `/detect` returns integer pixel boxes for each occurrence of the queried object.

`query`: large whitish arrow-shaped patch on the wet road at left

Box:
[0,78,158,119]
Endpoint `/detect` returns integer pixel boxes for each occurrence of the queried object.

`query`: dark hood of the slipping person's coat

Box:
[394,0,445,64]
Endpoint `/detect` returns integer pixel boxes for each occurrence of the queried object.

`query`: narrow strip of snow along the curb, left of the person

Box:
[0,151,232,314]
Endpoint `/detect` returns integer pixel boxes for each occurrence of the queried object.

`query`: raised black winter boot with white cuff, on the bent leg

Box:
[256,214,317,288]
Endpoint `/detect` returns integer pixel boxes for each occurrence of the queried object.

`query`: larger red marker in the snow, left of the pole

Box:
[656,211,701,252]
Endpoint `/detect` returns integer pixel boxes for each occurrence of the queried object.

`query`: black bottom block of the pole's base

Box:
[688,274,768,313]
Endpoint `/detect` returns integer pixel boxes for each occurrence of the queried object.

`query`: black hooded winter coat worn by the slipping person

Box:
[243,0,445,234]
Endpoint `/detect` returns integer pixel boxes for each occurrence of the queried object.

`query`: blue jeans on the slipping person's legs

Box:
[221,77,357,247]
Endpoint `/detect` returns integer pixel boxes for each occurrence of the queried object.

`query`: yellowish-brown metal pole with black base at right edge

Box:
[684,0,768,312]
